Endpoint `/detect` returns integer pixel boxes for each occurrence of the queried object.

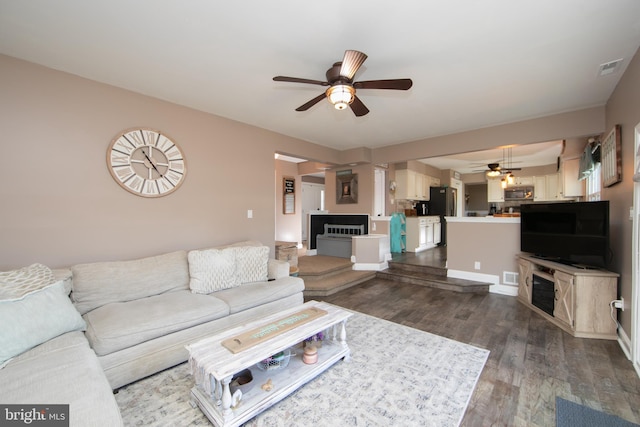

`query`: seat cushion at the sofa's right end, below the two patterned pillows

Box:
[215,276,304,314]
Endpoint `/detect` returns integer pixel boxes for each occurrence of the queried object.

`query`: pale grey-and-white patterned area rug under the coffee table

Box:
[116,313,489,427]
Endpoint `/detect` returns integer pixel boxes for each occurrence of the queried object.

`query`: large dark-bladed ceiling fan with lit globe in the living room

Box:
[273,50,413,117]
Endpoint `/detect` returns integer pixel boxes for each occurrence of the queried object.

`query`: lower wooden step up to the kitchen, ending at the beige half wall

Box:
[376,268,491,293]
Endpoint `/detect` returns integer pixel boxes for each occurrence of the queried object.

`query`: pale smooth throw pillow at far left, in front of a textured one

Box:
[0,281,86,368]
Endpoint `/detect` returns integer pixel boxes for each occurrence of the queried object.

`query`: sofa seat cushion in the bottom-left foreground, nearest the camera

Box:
[0,332,122,427]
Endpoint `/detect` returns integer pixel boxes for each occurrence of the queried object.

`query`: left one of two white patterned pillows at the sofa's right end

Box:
[188,248,240,294]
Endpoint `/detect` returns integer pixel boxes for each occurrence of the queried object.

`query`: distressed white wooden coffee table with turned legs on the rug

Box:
[187,301,352,427]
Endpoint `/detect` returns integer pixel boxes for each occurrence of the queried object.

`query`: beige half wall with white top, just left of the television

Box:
[445,216,520,296]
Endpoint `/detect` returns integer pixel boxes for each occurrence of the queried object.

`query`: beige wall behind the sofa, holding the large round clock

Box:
[0,56,337,269]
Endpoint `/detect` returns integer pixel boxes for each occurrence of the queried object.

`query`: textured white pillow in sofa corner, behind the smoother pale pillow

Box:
[0,264,56,300]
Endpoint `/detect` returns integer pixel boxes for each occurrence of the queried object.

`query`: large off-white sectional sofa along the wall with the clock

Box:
[0,242,304,426]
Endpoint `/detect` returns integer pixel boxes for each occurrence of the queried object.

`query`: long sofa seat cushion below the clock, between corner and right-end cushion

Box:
[83,291,229,355]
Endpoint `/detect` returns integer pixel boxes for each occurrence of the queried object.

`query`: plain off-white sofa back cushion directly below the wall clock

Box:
[71,251,189,314]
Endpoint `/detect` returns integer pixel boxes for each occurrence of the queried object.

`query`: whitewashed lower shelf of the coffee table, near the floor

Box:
[191,341,349,427]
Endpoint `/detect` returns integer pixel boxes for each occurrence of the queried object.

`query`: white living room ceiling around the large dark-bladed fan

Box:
[0,0,640,157]
